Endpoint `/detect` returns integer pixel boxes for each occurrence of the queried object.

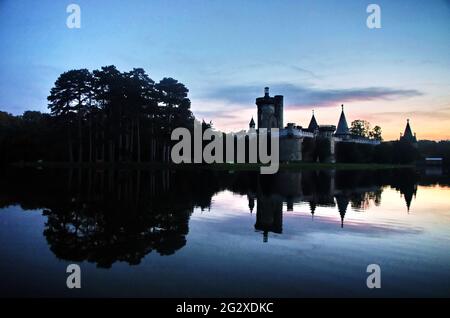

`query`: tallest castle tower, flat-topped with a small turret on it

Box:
[256,87,283,129]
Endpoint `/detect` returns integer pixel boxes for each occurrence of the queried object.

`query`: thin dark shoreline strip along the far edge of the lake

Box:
[11,162,415,171]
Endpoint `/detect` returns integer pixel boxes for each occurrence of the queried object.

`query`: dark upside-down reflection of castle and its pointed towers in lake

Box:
[247,170,417,242]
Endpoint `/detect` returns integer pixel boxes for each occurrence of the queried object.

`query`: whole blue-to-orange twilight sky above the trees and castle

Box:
[0,0,450,140]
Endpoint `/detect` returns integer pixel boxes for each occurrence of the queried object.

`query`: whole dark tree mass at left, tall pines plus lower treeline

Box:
[0,66,194,163]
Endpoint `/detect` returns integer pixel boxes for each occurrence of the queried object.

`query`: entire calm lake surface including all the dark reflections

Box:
[0,170,450,297]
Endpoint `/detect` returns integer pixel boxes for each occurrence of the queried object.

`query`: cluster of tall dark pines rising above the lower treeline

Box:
[48,66,194,162]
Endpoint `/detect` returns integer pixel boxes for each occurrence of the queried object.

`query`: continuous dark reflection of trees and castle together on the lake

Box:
[0,169,442,268]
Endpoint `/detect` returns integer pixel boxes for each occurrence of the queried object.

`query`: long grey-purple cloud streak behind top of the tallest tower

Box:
[205,83,423,108]
